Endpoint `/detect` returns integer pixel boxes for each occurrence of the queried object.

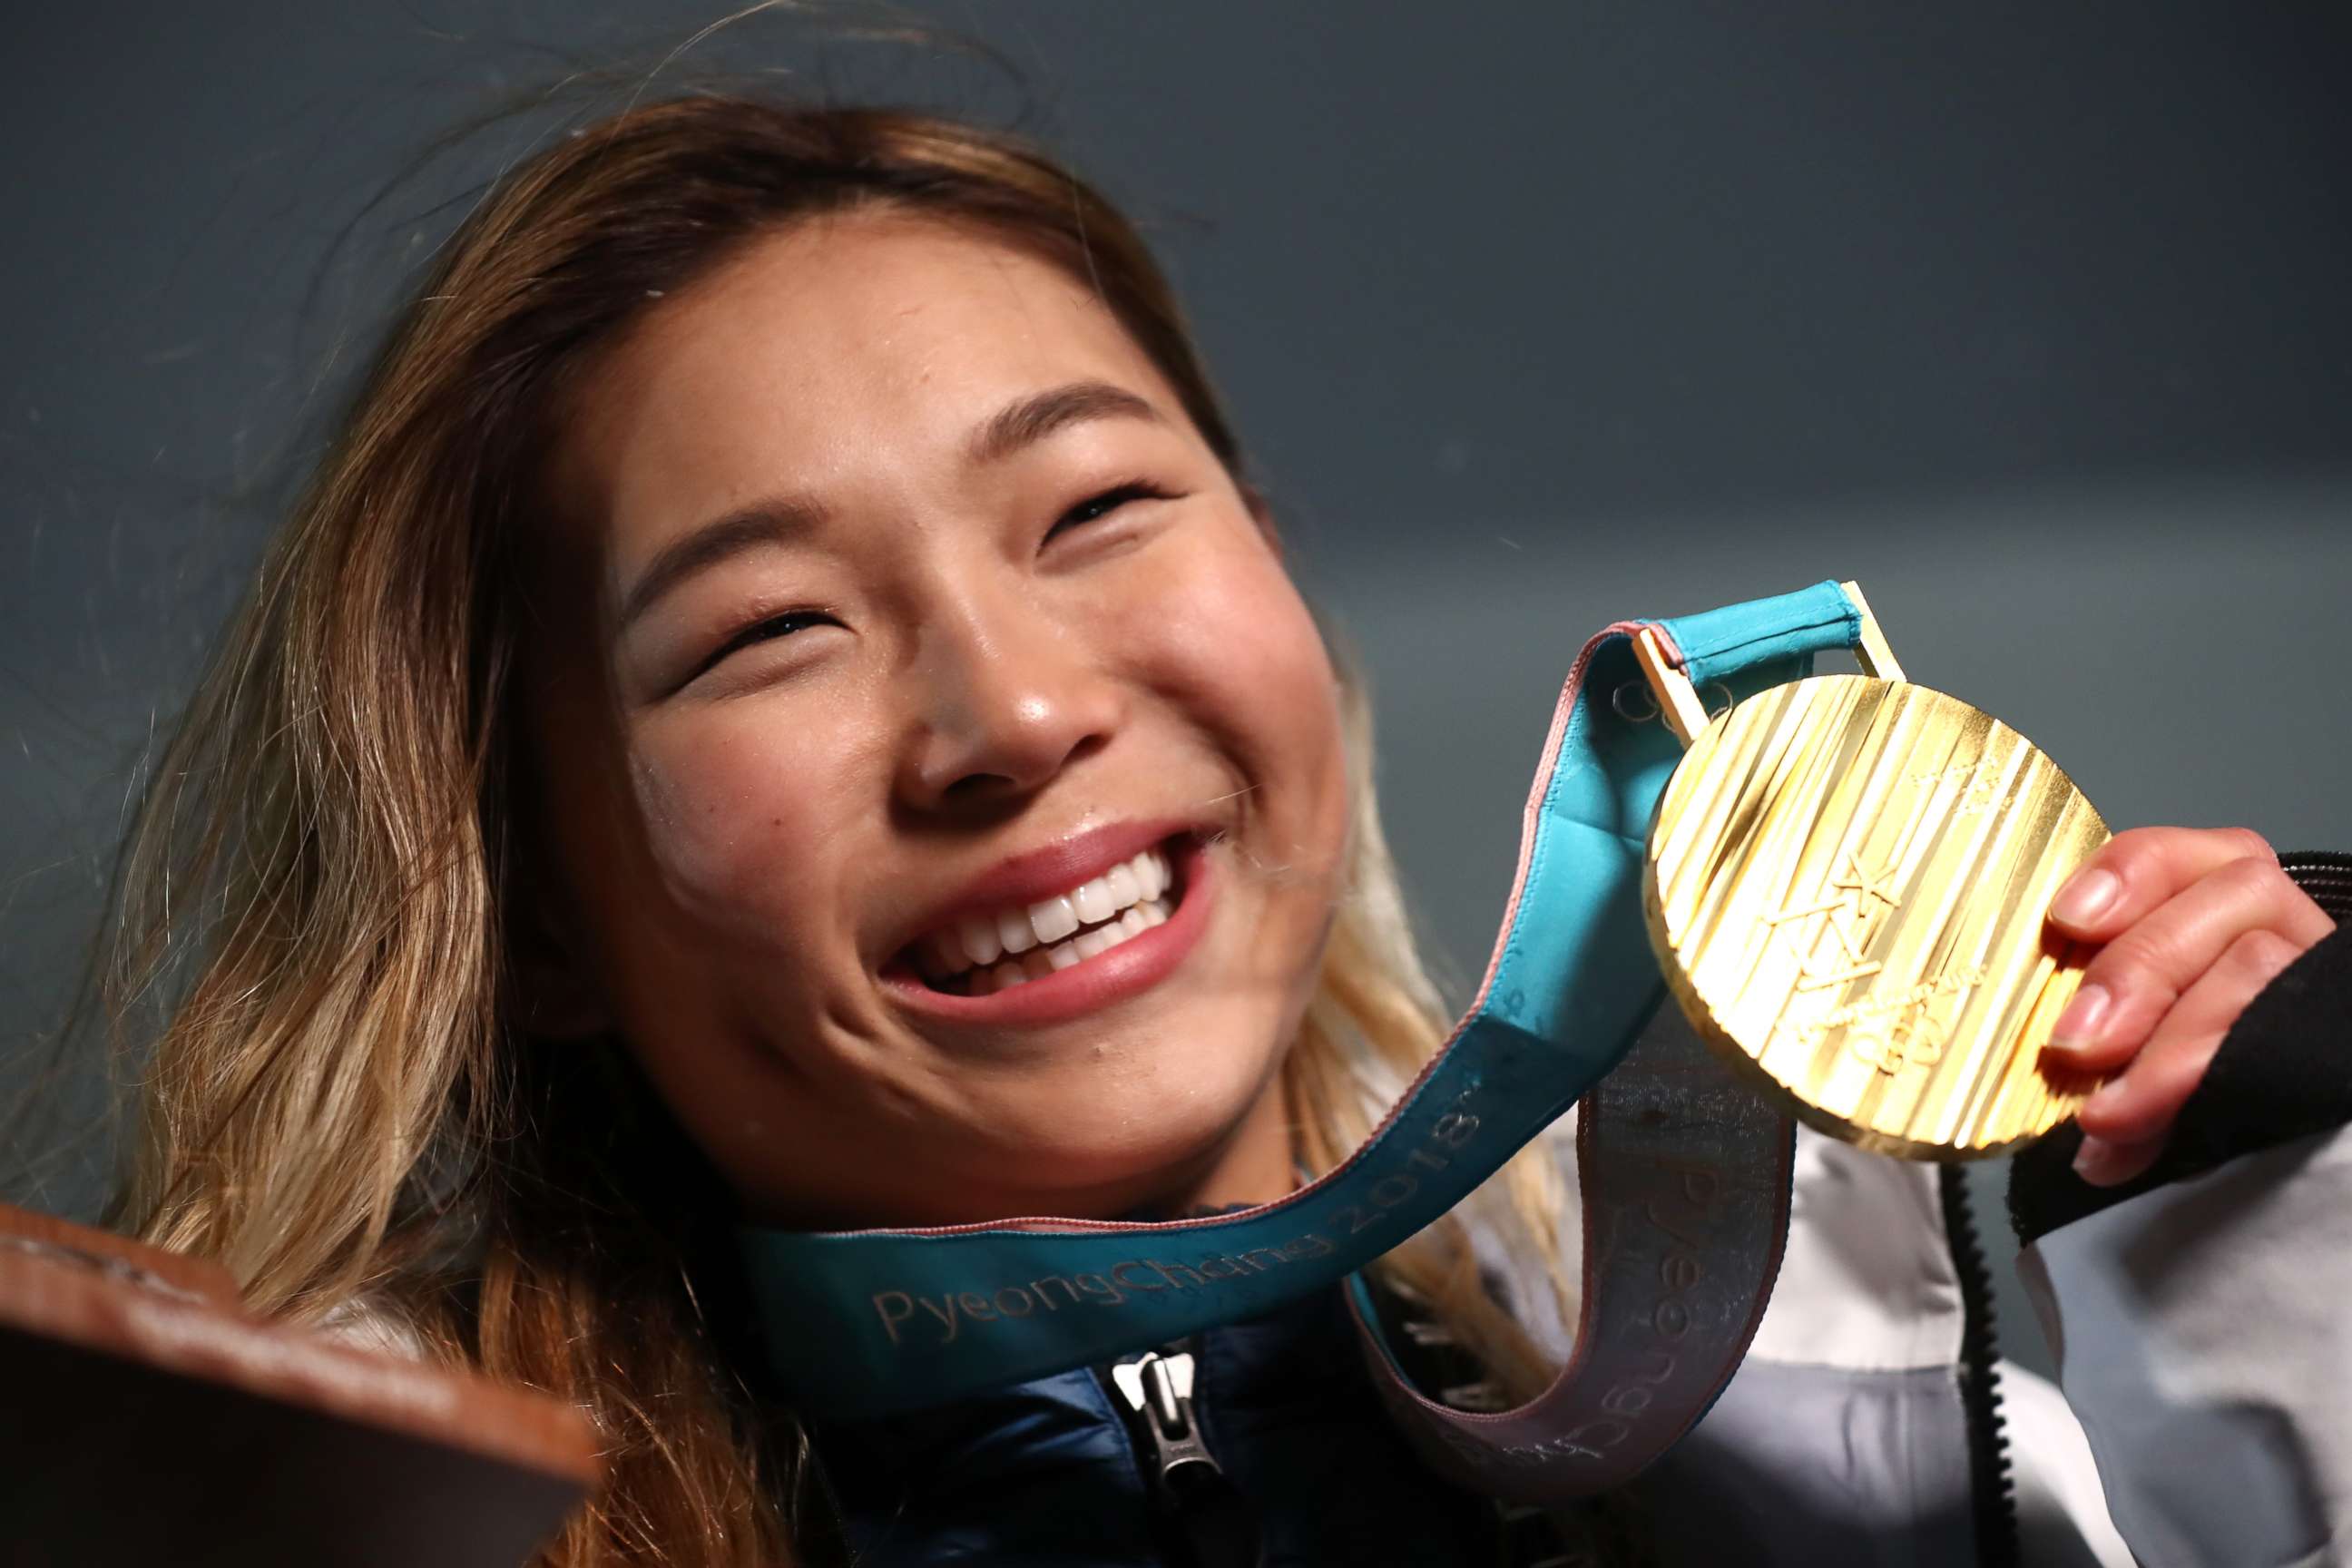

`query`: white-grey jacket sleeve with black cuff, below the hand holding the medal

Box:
[2011,856,2352,1568]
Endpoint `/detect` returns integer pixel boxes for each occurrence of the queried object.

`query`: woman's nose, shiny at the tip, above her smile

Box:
[898,606,1124,811]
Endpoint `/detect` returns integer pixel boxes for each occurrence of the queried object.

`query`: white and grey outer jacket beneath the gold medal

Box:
[1599,1048,2352,1568]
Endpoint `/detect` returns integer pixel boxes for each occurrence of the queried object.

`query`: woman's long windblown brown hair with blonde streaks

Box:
[108,96,1562,1568]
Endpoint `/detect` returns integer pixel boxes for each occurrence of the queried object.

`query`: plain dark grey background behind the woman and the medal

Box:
[0,0,2352,1364]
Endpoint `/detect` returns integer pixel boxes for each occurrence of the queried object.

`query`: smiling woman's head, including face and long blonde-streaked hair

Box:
[92,99,1562,1563]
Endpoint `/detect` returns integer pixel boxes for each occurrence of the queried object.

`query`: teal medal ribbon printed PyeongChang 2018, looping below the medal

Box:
[740,583,1860,1502]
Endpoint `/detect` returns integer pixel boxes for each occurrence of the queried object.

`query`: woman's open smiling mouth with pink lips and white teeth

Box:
[882,832,1209,1025]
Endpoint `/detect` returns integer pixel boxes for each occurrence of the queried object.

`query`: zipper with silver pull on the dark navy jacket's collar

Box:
[1096,1338,1260,1568]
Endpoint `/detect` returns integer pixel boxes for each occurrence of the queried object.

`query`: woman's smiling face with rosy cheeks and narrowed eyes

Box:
[524,216,1348,1225]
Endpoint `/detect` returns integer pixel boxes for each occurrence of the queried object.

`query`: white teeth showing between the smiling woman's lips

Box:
[908,848,1179,996]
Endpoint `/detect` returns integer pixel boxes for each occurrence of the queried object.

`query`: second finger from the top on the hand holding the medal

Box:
[2051,839,2331,1072]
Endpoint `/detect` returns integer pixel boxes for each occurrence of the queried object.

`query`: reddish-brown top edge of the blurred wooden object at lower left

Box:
[0,1210,603,1491]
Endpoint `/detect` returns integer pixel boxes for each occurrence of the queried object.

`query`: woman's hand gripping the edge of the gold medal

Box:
[2051,828,2336,1187]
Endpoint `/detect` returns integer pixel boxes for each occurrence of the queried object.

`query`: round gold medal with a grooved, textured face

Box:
[1644,675,2107,1159]
